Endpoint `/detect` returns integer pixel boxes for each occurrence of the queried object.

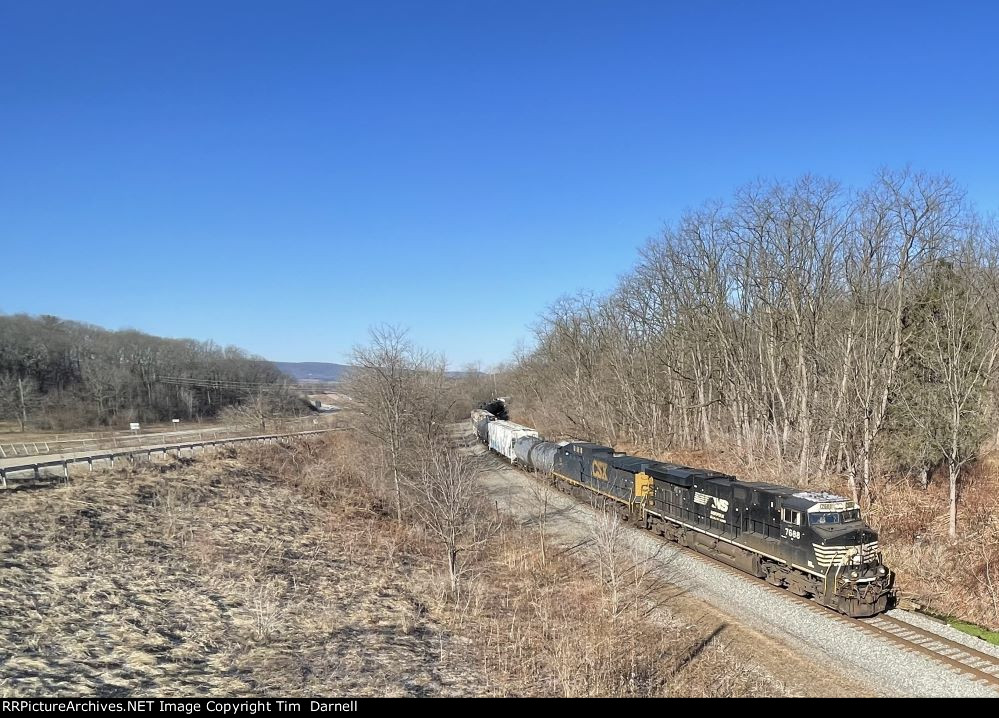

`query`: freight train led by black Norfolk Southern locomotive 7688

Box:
[471,409,894,617]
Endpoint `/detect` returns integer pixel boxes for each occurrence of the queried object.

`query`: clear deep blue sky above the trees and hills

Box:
[0,0,999,372]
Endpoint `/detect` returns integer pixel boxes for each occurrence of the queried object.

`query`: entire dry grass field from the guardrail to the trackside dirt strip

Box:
[0,436,783,696]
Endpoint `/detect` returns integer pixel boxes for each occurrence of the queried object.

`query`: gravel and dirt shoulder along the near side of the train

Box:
[468,436,999,697]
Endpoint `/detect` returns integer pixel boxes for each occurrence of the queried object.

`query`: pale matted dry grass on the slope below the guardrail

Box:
[0,438,478,696]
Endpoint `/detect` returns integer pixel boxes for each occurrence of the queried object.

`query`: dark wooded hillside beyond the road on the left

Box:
[0,314,294,431]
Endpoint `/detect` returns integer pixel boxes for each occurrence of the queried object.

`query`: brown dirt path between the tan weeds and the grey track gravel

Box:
[461,431,891,696]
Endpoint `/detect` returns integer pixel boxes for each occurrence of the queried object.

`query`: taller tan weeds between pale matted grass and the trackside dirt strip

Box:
[448,516,784,697]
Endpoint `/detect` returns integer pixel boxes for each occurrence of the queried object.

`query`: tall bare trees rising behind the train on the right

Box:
[511,170,999,535]
